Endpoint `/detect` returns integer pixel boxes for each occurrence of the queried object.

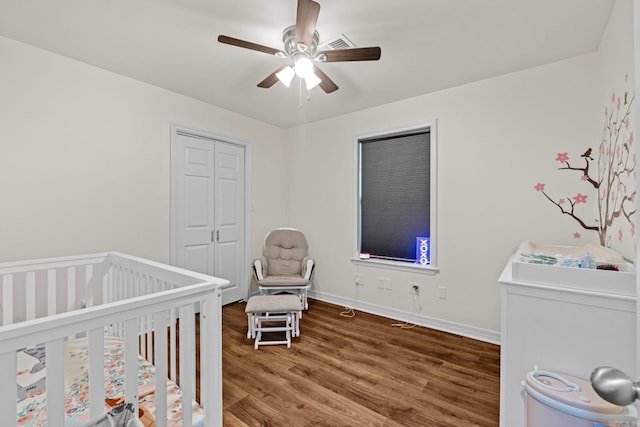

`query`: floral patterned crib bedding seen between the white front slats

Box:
[17,336,203,427]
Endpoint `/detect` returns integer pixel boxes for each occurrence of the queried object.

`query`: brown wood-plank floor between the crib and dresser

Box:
[222,300,500,427]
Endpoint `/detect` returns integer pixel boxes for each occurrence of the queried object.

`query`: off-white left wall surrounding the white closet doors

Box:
[0,37,284,262]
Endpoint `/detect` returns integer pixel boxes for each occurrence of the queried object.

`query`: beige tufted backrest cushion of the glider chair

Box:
[264,228,309,276]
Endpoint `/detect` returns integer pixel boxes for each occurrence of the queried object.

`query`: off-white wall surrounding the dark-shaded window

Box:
[288,54,601,335]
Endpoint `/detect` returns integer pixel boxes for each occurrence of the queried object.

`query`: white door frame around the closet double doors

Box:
[169,122,251,304]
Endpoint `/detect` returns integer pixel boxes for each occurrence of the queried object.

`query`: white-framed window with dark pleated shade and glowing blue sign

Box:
[357,123,436,268]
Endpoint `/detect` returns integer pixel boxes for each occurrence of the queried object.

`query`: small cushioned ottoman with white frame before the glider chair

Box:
[244,294,303,349]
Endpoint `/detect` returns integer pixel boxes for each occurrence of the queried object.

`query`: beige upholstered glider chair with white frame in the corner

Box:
[253,228,315,310]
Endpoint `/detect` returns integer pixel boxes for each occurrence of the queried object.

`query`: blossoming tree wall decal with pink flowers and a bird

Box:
[534,92,636,246]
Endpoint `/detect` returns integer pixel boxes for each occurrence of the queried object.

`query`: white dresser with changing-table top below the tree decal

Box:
[499,252,637,427]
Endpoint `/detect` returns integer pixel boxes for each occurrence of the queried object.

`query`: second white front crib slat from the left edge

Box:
[45,338,64,426]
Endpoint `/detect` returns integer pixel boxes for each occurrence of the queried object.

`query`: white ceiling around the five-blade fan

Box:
[0,0,615,128]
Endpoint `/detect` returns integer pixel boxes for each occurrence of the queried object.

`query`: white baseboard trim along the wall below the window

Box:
[308,290,500,345]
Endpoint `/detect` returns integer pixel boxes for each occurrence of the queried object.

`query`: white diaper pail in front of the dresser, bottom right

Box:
[524,369,637,427]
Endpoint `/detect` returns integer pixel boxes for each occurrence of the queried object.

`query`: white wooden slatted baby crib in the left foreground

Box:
[0,252,229,427]
